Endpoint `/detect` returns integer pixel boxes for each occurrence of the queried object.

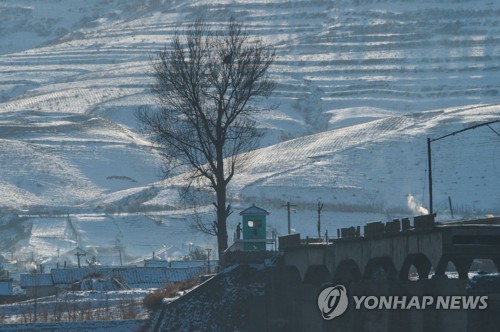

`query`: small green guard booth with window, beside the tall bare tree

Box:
[240,205,269,251]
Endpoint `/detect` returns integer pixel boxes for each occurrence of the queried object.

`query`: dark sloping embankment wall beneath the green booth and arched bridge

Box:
[151,264,500,332]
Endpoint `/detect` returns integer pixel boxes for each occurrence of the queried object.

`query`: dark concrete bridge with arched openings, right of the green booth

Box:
[280,216,500,283]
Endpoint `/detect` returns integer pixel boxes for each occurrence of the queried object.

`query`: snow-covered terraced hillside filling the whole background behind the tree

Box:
[0,0,500,262]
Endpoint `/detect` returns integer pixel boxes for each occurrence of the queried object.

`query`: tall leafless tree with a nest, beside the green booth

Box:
[137,18,275,257]
